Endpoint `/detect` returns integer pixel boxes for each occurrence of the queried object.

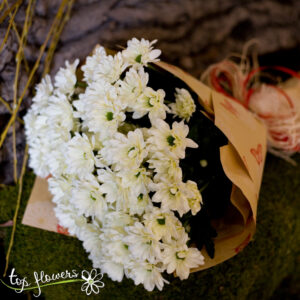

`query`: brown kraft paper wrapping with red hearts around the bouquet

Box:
[22,62,266,271]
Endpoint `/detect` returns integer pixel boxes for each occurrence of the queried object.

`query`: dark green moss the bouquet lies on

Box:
[0,155,300,300]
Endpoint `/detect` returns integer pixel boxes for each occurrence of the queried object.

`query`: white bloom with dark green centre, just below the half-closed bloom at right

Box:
[147,119,198,158]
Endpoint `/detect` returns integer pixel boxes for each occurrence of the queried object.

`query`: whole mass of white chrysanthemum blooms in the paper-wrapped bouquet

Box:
[25,38,204,291]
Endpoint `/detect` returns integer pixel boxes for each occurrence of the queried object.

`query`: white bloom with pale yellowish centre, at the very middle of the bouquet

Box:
[100,129,148,170]
